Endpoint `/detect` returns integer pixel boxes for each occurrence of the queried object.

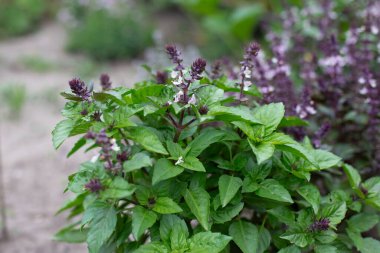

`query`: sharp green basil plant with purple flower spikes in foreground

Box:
[53,45,380,253]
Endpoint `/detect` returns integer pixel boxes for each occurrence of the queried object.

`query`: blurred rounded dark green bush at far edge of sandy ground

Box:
[64,0,153,60]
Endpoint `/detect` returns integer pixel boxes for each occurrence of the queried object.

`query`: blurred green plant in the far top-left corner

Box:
[0,0,52,37]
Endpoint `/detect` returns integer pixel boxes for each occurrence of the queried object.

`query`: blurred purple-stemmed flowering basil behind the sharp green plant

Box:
[212,0,380,178]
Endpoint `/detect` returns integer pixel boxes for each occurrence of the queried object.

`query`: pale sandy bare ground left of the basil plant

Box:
[0,24,137,253]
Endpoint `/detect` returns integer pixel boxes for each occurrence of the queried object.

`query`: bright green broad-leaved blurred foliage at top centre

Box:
[171,0,303,59]
